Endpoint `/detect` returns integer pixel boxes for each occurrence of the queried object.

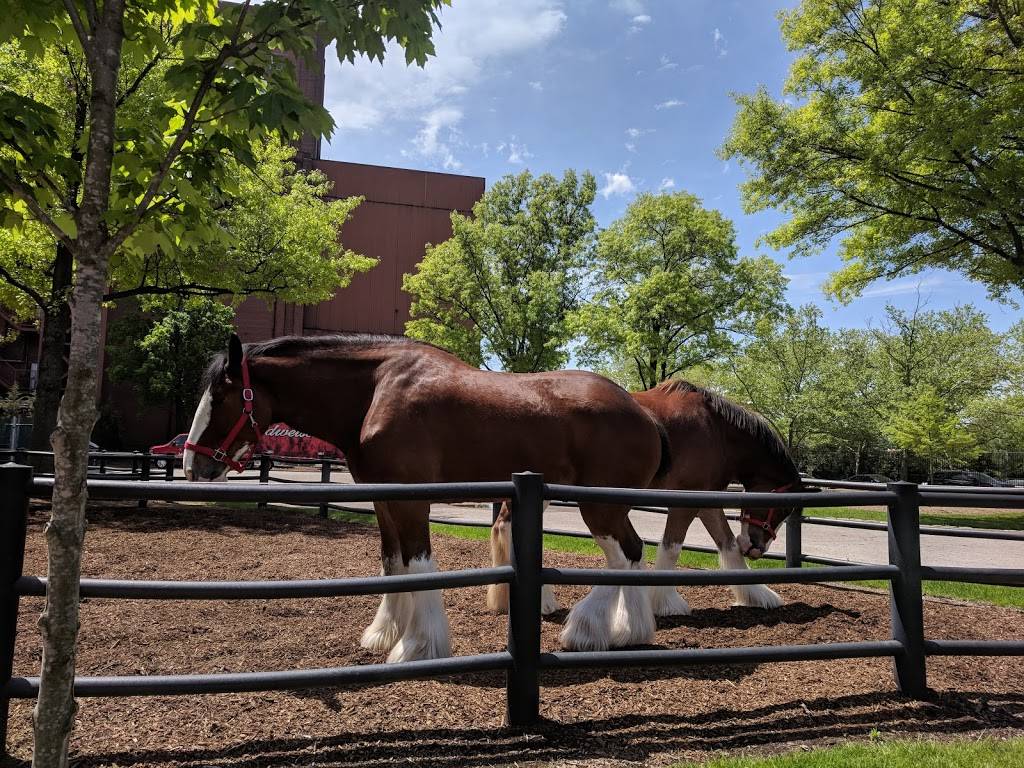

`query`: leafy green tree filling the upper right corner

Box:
[722,0,1024,299]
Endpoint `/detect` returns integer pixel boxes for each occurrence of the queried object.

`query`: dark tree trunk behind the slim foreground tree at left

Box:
[29,245,73,454]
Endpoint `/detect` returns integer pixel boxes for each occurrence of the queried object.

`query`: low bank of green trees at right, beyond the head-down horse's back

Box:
[702,305,1024,474]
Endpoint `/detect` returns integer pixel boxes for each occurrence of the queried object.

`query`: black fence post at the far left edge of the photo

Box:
[0,464,32,756]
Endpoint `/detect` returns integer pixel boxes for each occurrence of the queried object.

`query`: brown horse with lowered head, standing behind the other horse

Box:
[487,380,809,615]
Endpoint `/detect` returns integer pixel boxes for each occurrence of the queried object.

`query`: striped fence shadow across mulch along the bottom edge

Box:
[11,693,1024,768]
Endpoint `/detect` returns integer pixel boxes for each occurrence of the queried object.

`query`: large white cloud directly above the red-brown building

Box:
[325,0,567,138]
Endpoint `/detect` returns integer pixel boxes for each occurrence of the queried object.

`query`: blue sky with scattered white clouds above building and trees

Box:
[324,0,1021,330]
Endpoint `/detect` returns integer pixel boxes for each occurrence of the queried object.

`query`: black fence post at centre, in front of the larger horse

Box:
[506,472,544,725]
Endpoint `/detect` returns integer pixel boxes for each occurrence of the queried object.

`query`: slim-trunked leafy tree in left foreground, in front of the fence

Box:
[0,0,442,768]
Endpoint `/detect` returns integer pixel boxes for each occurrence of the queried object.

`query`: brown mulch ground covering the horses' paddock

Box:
[8,503,1024,768]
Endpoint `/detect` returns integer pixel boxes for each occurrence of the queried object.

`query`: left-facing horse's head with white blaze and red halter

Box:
[182,334,270,481]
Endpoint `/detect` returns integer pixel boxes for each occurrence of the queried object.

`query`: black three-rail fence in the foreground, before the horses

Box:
[0,464,1024,757]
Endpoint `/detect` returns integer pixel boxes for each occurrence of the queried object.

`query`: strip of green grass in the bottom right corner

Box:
[677,738,1024,768]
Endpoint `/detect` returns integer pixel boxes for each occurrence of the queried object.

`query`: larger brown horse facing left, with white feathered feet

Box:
[184,334,668,662]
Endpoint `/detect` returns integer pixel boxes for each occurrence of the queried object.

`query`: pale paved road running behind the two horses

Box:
[136,462,1024,568]
